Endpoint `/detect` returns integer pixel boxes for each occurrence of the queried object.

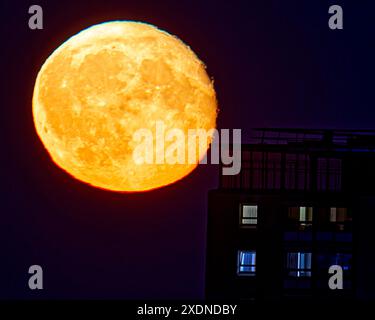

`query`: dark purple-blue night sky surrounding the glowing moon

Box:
[0,0,375,299]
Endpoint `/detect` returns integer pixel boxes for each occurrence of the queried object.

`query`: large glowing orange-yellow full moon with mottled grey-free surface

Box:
[32,21,217,192]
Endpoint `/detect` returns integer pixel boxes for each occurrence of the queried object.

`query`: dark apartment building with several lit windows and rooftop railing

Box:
[206,129,375,300]
